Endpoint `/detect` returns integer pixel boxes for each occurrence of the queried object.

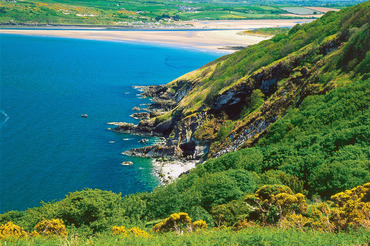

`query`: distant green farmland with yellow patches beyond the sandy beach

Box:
[0,0,362,26]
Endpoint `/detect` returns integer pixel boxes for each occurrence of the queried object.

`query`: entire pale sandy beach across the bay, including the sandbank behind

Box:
[0,19,312,52]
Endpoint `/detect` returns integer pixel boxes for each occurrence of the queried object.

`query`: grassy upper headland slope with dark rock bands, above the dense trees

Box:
[163,0,369,160]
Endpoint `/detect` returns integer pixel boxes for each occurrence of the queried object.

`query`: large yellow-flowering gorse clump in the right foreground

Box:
[237,183,370,232]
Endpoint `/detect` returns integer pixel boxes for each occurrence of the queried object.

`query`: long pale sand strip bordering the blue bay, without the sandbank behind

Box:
[0,29,272,54]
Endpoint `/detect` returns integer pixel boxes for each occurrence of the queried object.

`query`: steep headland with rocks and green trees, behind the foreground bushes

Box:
[111,2,370,221]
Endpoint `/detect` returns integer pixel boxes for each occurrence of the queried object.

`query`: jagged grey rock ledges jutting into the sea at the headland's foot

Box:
[108,84,207,160]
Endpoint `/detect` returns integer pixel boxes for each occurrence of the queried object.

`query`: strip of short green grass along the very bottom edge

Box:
[4,227,370,246]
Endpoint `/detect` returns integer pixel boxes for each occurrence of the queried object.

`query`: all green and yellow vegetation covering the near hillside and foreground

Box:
[0,2,370,245]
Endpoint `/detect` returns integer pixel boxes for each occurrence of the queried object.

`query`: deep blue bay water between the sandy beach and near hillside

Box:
[0,35,221,212]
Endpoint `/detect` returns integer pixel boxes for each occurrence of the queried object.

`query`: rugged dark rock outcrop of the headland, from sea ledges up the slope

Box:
[113,20,341,164]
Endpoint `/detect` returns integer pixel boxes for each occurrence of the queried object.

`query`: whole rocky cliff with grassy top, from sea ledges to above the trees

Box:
[114,2,370,163]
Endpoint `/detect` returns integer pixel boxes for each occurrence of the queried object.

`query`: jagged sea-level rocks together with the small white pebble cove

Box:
[107,83,205,184]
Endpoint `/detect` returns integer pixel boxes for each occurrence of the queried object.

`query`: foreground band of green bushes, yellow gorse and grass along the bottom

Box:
[0,183,370,245]
